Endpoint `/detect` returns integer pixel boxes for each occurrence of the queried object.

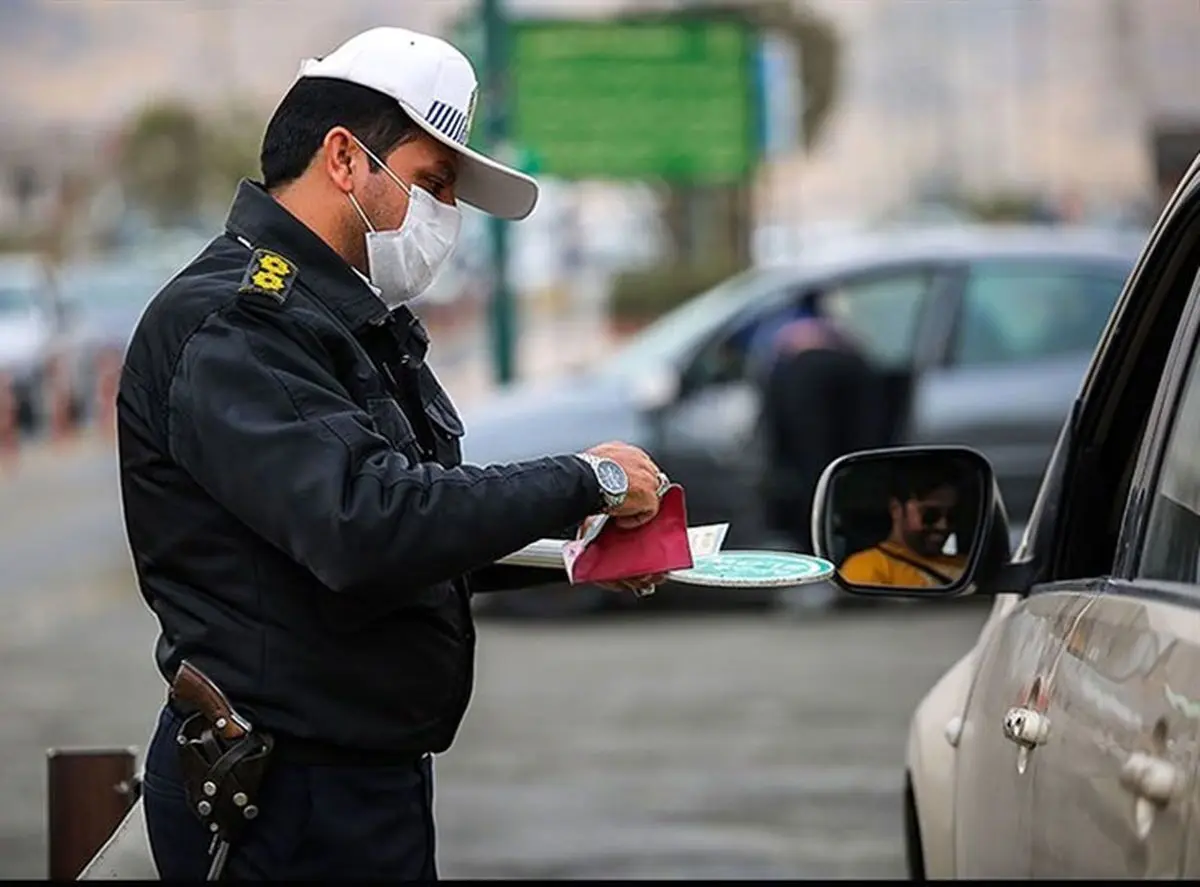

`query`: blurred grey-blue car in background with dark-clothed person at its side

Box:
[464,226,1144,616]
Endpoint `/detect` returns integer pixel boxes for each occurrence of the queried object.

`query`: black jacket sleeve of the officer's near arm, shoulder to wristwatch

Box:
[168,308,601,593]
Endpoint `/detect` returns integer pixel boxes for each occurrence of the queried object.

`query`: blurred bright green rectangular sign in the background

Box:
[509,18,758,184]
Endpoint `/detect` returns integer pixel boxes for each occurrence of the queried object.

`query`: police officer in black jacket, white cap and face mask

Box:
[118,28,665,880]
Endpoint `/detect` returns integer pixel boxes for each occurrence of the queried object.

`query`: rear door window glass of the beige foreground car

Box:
[1138,331,1200,583]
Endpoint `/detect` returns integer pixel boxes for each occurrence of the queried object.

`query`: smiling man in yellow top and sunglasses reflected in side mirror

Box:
[839,461,970,588]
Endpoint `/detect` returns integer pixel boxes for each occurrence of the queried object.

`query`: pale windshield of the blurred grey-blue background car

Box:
[605,268,796,376]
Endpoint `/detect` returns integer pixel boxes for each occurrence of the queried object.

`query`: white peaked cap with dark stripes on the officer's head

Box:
[300,28,538,220]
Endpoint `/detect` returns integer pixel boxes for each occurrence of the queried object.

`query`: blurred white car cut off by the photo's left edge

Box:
[0,256,58,430]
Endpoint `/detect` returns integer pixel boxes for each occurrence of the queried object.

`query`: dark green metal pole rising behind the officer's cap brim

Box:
[480,0,516,385]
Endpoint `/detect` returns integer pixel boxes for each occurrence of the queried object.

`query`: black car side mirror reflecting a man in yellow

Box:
[812,447,1012,598]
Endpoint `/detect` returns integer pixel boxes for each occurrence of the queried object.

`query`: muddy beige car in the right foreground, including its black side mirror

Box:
[814,160,1200,880]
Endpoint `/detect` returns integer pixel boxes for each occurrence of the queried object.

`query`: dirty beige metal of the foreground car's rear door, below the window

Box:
[1032,586,1200,879]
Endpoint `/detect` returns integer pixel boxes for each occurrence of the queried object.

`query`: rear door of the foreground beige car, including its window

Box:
[1032,261,1200,879]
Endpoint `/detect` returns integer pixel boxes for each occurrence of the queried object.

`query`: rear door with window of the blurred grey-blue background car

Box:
[907,259,1128,522]
